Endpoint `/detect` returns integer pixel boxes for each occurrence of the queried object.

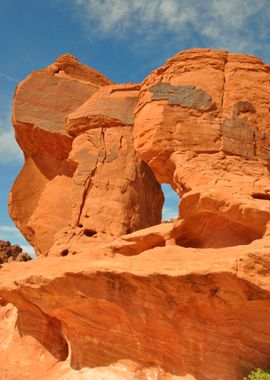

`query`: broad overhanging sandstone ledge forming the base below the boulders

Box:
[0,243,270,380]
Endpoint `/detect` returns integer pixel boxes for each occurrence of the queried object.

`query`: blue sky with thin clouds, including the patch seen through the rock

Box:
[0,0,270,255]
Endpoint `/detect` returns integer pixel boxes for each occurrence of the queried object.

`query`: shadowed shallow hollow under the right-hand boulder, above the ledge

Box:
[174,213,264,248]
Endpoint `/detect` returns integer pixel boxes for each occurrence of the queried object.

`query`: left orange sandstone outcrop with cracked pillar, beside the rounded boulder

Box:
[9,55,163,255]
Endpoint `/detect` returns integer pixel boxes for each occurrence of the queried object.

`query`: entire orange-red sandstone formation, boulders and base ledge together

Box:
[0,49,270,380]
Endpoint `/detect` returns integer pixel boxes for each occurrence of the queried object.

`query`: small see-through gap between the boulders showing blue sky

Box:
[161,184,179,223]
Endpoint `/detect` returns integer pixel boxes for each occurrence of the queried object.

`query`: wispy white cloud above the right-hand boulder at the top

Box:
[72,0,270,59]
